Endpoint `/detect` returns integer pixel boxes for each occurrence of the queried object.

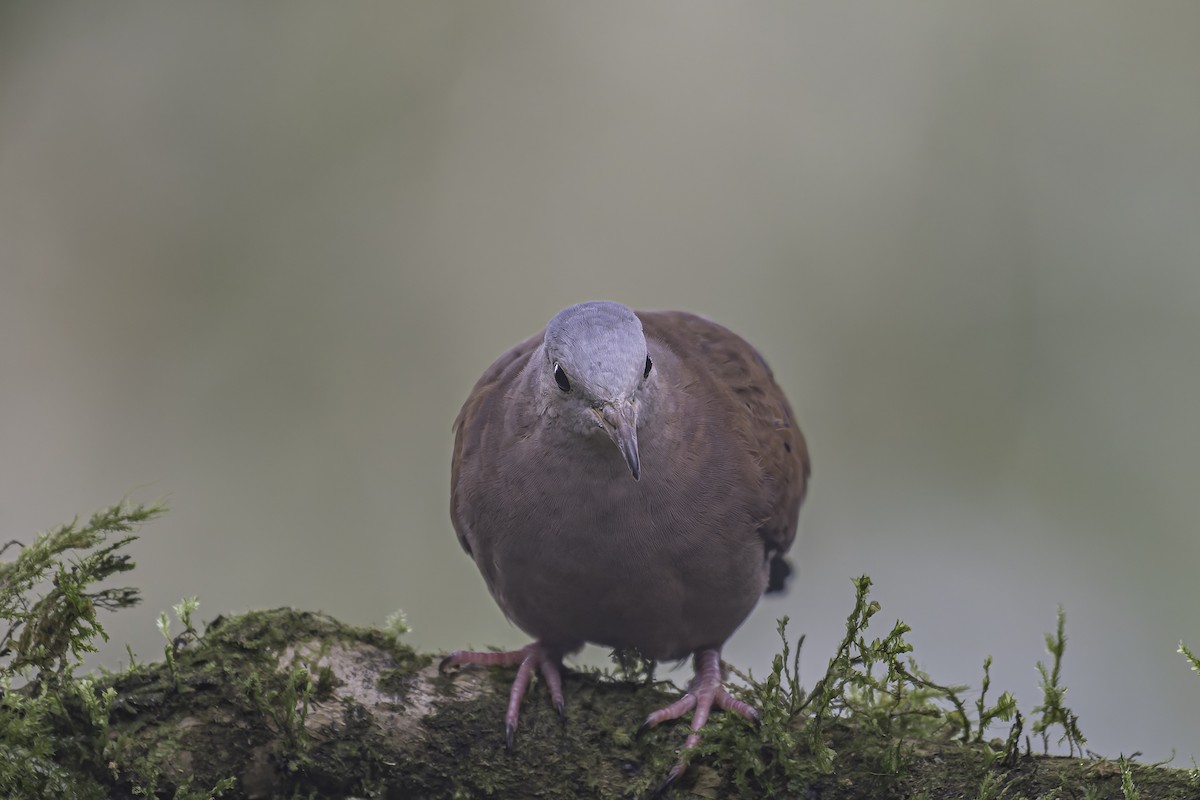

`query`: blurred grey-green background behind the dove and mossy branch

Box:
[0,0,1200,765]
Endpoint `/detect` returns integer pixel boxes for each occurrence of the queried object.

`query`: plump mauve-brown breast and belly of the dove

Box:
[463,424,766,657]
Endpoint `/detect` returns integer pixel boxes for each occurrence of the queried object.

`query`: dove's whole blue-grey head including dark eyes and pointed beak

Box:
[541,301,653,480]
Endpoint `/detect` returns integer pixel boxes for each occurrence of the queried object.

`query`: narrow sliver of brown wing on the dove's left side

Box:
[450,331,545,558]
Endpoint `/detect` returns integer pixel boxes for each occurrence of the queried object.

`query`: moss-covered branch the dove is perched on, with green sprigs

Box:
[0,510,1200,800]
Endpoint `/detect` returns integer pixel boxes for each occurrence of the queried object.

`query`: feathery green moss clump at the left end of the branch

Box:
[0,504,241,800]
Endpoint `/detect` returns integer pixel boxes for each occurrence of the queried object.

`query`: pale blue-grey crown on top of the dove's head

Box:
[545,301,647,401]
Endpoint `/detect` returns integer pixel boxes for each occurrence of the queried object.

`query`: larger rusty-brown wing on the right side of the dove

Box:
[637,311,811,590]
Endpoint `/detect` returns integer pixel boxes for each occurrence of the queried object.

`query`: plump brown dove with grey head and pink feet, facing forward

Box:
[440,301,811,786]
